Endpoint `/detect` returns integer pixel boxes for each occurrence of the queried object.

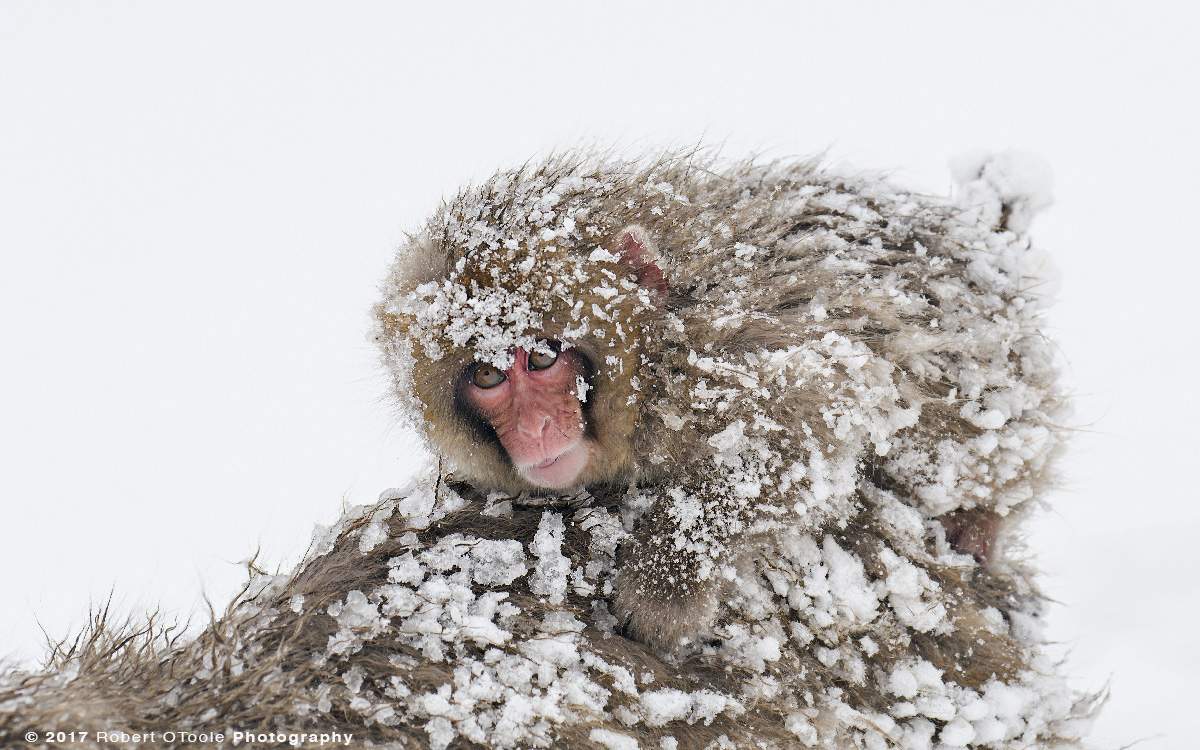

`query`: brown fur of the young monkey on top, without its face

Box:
[377,156,1058,646]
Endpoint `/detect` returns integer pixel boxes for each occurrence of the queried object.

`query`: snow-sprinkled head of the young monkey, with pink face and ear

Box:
[377,195,666,493]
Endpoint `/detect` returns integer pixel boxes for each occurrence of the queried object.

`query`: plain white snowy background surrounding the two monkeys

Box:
[0,1,1200,750]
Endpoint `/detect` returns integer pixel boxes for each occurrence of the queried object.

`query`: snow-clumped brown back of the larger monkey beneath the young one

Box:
[0,474,1094,750]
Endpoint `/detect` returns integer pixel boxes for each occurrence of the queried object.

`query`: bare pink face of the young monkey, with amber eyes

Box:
[463,349,592,490]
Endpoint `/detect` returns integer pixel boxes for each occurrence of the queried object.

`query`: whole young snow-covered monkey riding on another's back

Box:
[376,154,1060,647]
